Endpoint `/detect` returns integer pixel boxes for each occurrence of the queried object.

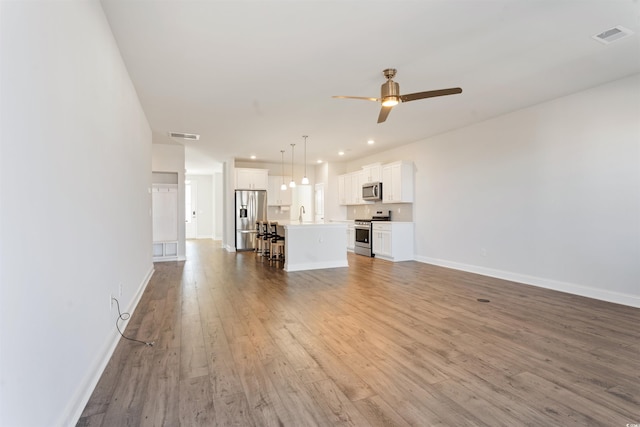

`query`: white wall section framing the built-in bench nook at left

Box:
[151,142,186,260]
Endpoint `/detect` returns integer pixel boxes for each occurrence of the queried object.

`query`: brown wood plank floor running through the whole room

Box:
[77,240,640,427]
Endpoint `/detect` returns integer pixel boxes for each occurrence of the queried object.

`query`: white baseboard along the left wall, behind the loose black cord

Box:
[65,264,155,426]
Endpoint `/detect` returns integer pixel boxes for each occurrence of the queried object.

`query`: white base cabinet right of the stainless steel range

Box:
[371,221,413,261]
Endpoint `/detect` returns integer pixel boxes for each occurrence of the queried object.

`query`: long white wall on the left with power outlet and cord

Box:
[0,1,153,427]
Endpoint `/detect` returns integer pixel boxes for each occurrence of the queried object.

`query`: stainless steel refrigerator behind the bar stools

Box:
[236,190,267,251]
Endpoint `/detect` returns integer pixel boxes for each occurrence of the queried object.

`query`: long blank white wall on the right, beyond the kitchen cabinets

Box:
[349,75,640,306]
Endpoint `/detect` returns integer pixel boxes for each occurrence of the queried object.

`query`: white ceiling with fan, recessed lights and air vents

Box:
[102,0,640,172]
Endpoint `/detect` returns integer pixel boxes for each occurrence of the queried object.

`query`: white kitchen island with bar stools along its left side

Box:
[278,221,349,271]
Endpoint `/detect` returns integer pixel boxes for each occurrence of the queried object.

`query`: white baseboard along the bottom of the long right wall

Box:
[415,256,640,308]
